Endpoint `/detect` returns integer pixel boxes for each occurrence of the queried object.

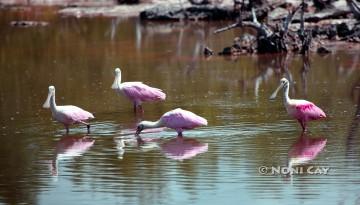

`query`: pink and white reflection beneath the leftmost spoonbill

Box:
[51,135,95,176]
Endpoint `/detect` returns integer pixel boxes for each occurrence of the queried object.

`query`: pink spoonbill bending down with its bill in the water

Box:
[136,108,207,137]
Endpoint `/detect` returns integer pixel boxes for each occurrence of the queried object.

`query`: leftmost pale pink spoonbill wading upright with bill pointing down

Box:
[43,86,94,133]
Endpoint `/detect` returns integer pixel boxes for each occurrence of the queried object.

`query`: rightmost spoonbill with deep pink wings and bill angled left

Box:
[270,78,326,132]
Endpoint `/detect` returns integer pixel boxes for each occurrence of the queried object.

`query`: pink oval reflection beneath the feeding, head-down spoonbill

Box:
[160,137,208,161]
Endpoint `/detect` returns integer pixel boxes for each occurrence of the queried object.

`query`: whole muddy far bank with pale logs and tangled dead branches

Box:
[1,0,360,55]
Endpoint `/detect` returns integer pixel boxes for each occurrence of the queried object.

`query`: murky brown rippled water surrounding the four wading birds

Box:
[0,8,360,204]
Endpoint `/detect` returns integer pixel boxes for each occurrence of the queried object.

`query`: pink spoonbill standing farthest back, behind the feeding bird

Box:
[111,68,166,112]
